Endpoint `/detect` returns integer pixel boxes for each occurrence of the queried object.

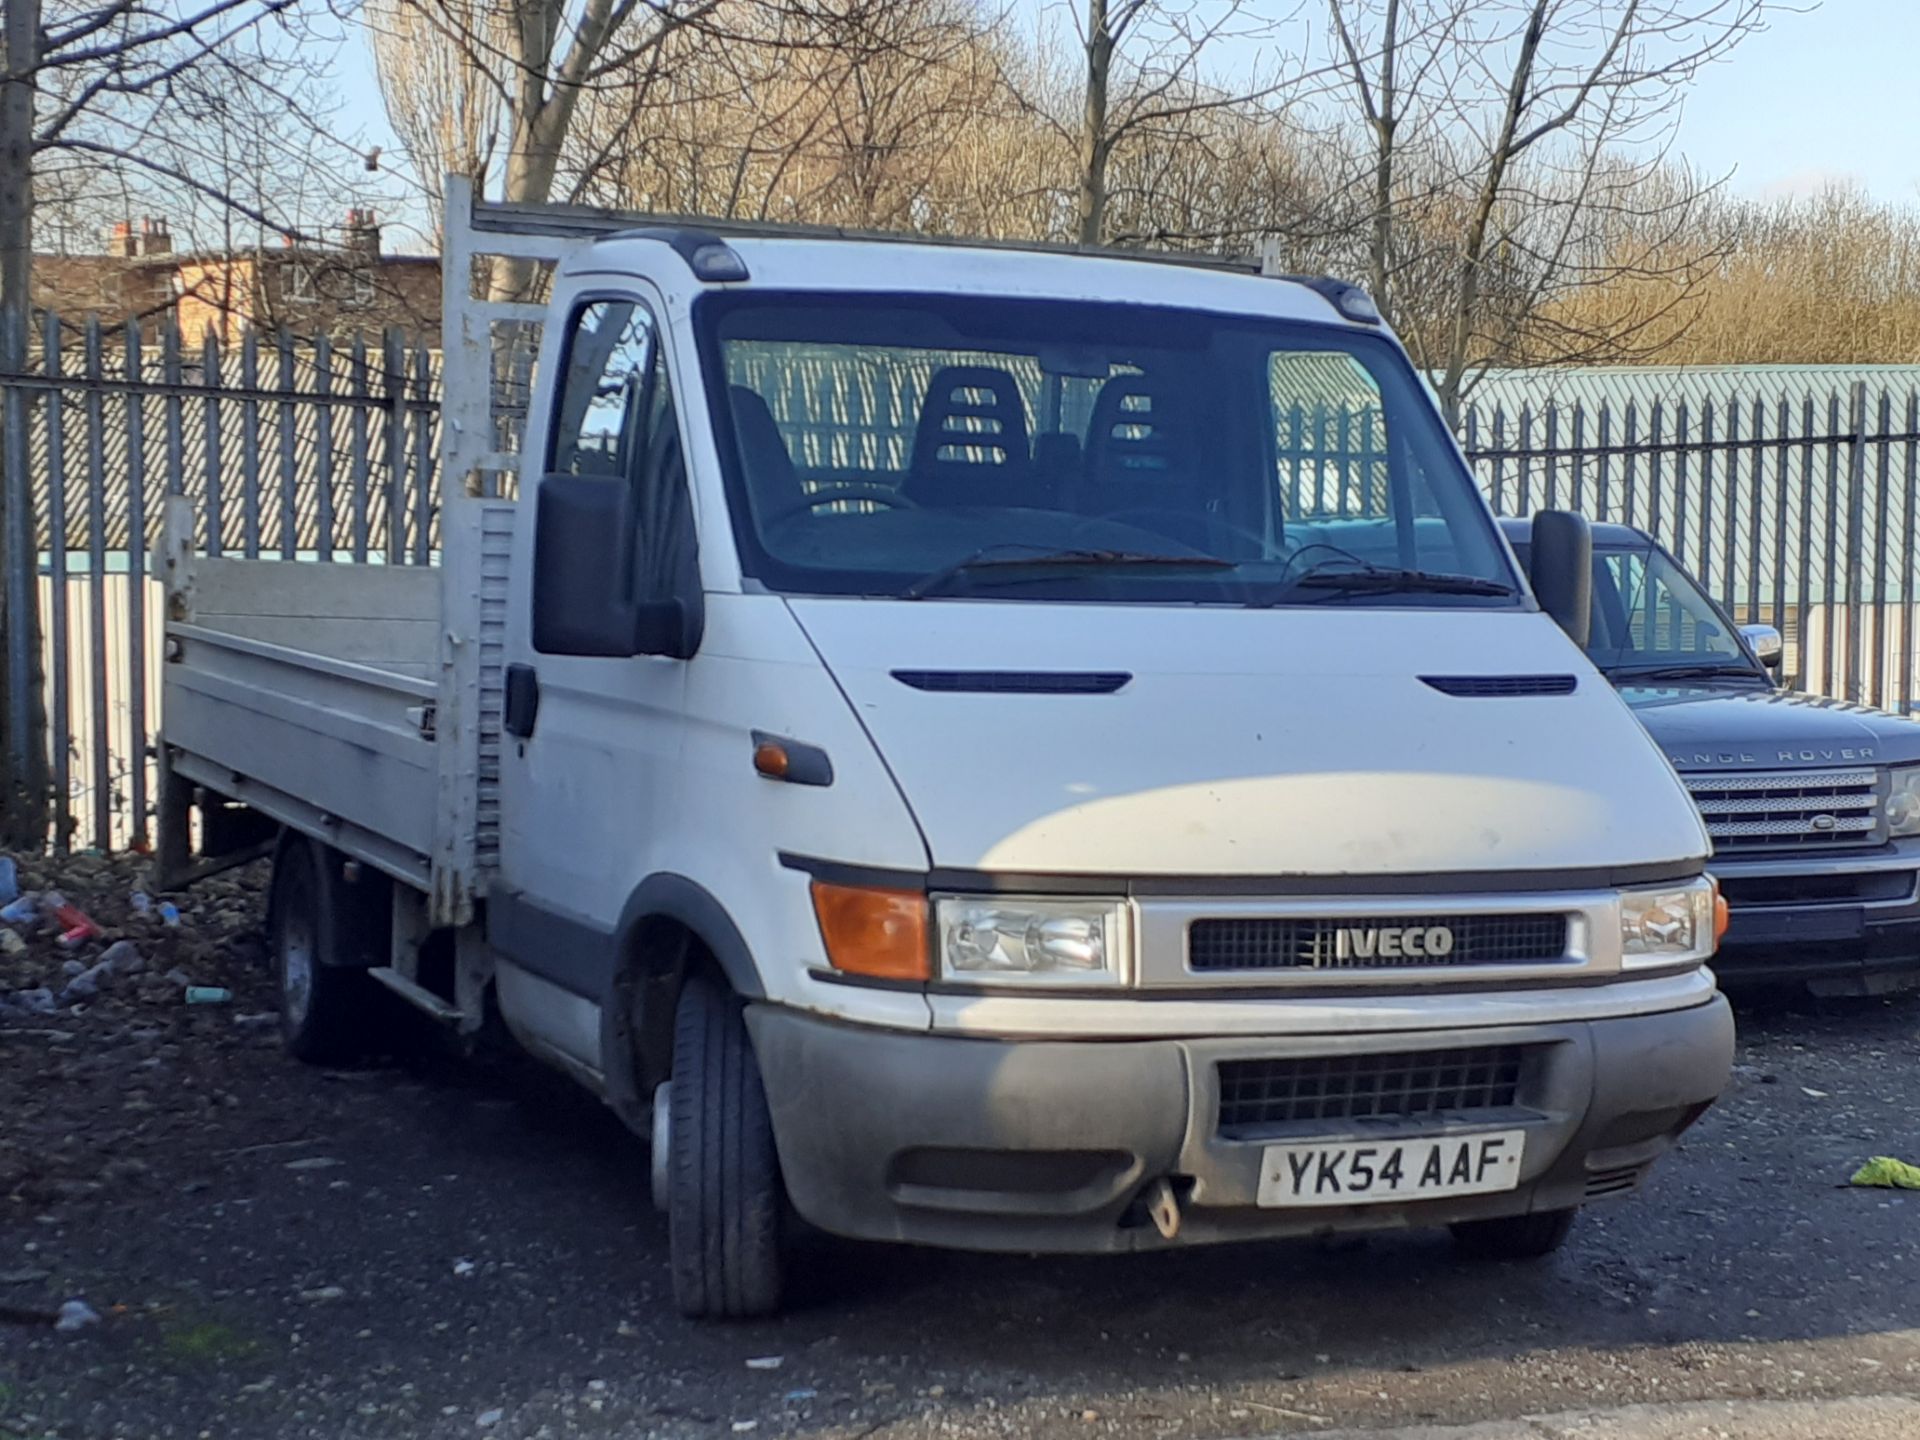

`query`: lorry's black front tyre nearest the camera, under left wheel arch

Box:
[664,975,785,1319]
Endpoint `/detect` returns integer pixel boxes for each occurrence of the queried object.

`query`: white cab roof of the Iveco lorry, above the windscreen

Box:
[564,234,1373,330]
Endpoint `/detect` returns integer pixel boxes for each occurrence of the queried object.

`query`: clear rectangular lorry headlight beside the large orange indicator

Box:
[933,895,1129,985]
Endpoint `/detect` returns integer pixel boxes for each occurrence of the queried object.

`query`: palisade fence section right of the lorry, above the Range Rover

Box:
[1461,384,1920,714]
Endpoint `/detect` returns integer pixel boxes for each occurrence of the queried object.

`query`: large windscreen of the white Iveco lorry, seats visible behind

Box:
[695,292,1523,607]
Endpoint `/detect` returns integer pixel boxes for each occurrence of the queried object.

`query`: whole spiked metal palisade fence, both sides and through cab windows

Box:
[11,303,1920,849]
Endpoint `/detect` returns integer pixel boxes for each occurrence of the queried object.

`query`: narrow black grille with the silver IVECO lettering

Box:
[1187,914,1567,972]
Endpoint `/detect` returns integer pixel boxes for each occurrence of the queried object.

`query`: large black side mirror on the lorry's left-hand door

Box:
[534,474,699,660]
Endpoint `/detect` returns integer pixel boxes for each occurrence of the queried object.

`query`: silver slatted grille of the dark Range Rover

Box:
[1686,768,1885,854]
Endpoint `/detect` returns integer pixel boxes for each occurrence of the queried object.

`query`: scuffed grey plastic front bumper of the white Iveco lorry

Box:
[747,995,1734,1252]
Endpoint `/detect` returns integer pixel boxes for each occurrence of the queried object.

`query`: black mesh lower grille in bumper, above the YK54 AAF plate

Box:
[1217,1044,1526,1139]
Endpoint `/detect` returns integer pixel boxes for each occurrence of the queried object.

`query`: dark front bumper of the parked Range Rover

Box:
[1713,839,1920,993]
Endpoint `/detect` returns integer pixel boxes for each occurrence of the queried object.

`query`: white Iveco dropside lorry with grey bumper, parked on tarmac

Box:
[163,182,1732,1315]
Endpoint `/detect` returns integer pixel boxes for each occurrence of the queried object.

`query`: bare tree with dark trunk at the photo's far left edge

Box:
[0,0,378,845]
